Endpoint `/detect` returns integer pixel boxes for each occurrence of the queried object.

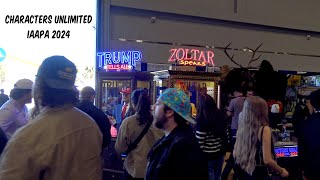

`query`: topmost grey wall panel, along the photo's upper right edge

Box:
[111,0,320,32]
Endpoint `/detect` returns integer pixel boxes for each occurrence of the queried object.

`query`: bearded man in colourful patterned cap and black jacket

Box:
[146,88,208,180]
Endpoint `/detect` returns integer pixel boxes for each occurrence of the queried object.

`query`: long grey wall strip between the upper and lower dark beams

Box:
[111,11,320,55]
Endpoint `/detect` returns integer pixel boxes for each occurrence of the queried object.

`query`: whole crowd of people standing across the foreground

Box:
[0,56,320,180]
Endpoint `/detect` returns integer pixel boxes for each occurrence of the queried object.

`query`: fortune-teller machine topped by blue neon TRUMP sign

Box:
[96,51,153,179]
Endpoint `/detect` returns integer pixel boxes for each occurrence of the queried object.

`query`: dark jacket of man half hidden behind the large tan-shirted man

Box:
[77,100,111,148]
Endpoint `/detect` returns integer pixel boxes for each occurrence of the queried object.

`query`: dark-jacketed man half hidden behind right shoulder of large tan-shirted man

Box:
[77,86,111,149]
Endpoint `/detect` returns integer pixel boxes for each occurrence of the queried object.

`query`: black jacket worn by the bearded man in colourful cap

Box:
[146,126,208,180]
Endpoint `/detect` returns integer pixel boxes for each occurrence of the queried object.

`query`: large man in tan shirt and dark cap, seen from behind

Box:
[0,56,102,180]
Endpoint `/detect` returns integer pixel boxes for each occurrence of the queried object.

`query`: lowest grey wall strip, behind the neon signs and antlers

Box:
[111,40,320,72]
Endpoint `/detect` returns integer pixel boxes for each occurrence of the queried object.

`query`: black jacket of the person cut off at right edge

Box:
[298,113,320,180]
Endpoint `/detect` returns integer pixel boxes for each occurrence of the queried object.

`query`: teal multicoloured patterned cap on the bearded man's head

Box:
[159,88,196,124]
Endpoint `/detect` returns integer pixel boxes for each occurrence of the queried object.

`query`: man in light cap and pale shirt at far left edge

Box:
[0,79,33,139]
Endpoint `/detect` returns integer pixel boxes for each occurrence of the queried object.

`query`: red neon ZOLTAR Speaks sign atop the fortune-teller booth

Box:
[168,48,214,66]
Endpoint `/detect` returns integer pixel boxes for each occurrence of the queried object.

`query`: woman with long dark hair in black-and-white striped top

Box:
[196,94,228,180]
